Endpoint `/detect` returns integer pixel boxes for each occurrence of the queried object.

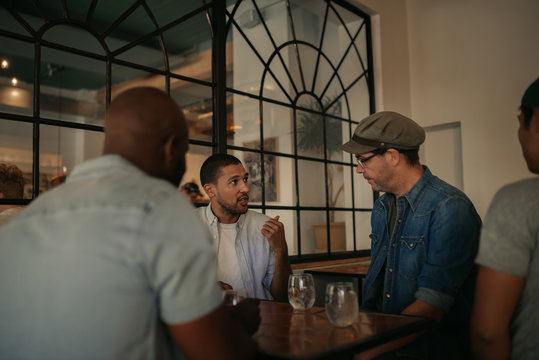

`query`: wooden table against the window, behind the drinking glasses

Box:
[305,263,369,306]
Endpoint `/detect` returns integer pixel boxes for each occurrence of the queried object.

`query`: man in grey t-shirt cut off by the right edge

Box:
[472,79,539,360]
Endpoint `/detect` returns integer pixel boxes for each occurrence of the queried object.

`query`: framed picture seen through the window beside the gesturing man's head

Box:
[243,137,279,202]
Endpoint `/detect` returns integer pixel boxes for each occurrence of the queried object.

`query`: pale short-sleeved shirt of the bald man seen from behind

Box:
[0,155,222,360]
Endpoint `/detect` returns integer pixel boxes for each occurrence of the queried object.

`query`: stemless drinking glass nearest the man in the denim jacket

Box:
[326,282,358,326]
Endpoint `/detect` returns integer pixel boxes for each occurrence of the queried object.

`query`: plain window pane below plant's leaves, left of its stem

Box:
[298,160,326,206]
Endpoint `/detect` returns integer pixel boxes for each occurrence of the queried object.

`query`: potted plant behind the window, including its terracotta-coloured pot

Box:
[297,97,346,252]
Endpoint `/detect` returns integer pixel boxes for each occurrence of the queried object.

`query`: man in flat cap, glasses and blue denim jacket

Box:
[342,111,481,359]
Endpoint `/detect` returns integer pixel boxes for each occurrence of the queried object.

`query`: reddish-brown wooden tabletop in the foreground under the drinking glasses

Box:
[253,301,434,360]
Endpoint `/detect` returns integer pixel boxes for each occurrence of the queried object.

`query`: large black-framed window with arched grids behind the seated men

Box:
[0,0,374,261]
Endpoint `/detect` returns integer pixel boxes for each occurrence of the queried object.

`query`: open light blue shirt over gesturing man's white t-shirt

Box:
[197,203,275,299]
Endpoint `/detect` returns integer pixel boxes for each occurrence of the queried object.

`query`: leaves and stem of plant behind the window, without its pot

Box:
[297,97,344,222]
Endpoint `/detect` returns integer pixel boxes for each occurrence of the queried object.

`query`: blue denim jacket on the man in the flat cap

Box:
[363,166,481,314]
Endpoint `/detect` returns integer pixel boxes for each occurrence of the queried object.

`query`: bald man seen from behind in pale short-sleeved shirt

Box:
[0,87,260,359]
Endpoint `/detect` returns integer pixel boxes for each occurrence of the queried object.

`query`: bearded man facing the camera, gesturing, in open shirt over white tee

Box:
[197,154,291,301]
